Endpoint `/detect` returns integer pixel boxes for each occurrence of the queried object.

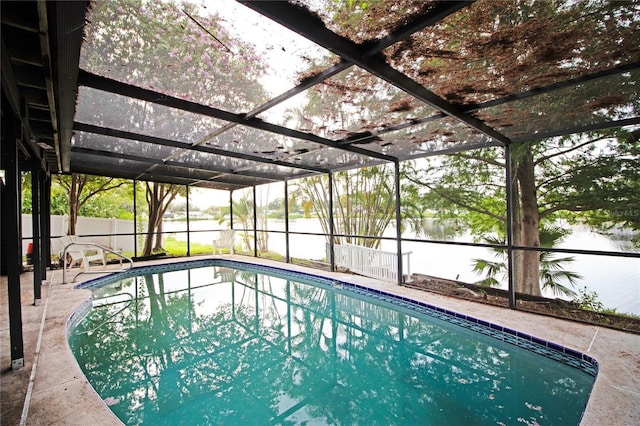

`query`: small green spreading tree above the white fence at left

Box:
[54,173,127,235]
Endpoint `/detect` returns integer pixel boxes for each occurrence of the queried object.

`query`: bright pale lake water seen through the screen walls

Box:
[164,219,640,315]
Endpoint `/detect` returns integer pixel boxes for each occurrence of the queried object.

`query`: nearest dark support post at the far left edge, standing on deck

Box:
[2,107,24,370]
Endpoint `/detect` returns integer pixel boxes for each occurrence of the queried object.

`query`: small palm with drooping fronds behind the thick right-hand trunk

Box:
[473,225,582,297]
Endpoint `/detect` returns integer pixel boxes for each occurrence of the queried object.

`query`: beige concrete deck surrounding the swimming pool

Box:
[0,255,640,426]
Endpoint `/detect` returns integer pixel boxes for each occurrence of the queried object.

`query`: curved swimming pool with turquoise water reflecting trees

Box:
[68,260,597,425]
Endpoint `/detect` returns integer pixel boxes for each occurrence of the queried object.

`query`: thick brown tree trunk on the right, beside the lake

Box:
[514,149,541,296]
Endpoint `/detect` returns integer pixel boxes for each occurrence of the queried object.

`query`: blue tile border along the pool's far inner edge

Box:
[76,259,599,377]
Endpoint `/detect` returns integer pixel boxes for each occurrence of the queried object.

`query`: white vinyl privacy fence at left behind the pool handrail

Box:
[22,214,135,254]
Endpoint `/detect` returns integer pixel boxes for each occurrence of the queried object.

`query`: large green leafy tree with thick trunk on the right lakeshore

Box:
[406,129,640,295]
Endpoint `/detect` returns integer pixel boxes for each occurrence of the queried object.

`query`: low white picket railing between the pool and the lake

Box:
[327,244,411,282]
